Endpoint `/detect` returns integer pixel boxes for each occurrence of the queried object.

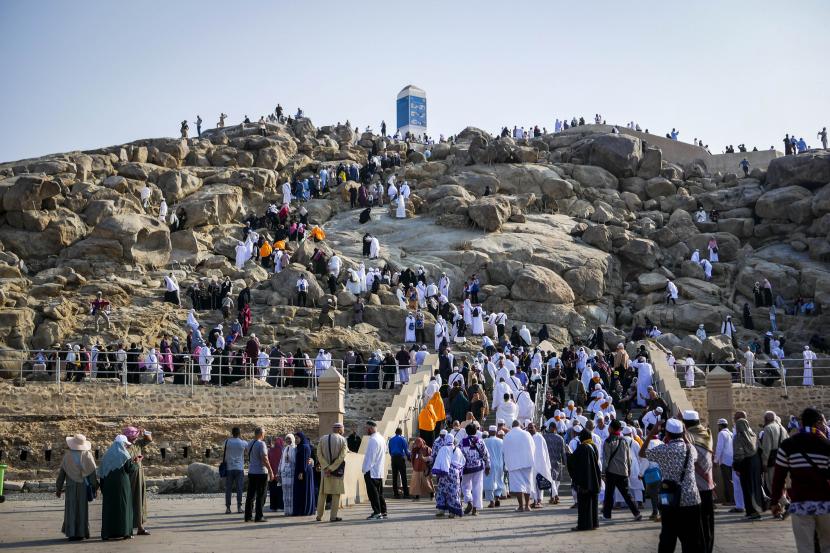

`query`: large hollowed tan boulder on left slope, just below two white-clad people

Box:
[91,213,171,267]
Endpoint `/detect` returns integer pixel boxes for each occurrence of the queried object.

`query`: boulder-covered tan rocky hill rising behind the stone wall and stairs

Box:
[0,119,830,378]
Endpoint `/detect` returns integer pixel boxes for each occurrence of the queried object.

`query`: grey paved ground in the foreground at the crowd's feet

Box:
[0,496,795,553]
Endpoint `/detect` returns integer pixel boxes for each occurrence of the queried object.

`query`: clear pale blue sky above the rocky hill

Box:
[0,0,830,161]
